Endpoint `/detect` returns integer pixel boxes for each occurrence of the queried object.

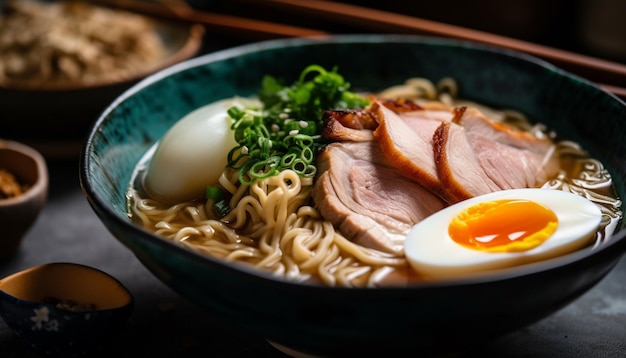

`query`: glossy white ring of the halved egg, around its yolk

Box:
[405,188,602,279]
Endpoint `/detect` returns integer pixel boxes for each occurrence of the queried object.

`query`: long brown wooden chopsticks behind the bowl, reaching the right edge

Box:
[254,0,626,99]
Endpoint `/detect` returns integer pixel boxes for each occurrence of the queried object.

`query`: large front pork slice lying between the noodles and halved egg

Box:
[312,142,446,256]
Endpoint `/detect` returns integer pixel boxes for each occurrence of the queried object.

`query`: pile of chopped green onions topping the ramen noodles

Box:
[228,65,369,185]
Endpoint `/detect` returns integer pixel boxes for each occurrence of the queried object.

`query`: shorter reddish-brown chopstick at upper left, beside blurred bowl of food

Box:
[94,0,328,40]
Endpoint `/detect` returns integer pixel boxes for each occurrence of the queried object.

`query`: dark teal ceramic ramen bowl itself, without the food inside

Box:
[80,35,626,357]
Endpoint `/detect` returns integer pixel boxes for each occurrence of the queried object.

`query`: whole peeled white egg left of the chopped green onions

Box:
[144,98,256,202]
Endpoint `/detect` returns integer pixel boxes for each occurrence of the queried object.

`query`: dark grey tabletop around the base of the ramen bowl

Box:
[0,160,626,358]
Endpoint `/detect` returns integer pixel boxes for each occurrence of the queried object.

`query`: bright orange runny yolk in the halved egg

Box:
[448,199,558,252]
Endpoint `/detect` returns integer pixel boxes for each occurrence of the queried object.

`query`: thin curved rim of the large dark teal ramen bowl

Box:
[79,34,626,294]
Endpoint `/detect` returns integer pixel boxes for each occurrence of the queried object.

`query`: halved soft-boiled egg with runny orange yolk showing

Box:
[405,188,602,279]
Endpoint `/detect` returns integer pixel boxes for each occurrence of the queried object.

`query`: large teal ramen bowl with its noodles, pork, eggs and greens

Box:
[80,35,626,356]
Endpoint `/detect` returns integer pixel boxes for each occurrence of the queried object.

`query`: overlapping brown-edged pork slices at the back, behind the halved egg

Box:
[372,100,559,204]
